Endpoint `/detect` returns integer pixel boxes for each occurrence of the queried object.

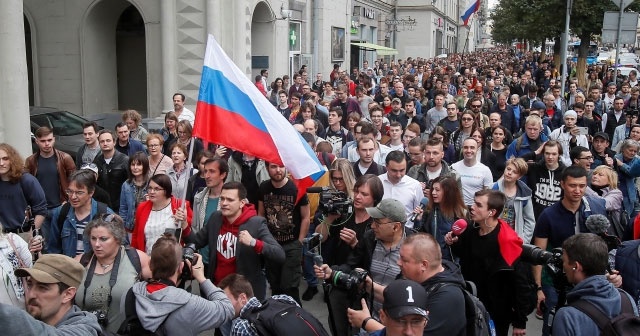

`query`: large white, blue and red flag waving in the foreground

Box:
[193,35,324,197]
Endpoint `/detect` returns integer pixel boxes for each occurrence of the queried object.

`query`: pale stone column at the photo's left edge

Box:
[0,0,31,158]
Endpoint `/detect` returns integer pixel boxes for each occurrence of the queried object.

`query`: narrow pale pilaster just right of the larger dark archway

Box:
[160,1,178,110]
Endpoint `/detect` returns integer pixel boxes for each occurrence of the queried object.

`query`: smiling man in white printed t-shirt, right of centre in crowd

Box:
[451,138,493,205]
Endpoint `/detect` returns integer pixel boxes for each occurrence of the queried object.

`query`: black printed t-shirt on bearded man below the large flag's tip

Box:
[258,180,309,244]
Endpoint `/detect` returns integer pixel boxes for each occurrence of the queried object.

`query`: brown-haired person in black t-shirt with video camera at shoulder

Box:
[316,173,384,335]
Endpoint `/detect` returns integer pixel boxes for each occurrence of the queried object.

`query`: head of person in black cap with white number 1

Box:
[365,280,429,336]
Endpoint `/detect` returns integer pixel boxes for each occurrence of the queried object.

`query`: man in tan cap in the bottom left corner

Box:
[0,254,102,336]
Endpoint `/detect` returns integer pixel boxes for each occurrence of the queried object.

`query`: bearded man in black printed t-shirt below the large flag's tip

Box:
[258,162,310,305]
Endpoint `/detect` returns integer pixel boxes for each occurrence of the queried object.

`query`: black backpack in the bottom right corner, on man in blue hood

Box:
[570,288,640,336]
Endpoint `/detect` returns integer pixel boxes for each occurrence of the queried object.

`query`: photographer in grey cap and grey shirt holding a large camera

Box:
[315,199,415,335]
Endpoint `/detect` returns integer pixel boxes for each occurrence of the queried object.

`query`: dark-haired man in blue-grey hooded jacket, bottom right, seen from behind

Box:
[553,233,640,336]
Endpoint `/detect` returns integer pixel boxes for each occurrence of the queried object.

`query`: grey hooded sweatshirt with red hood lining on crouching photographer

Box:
[133,279,235,336]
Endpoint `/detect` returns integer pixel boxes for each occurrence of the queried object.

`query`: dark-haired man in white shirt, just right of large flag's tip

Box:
[379,151,424,228]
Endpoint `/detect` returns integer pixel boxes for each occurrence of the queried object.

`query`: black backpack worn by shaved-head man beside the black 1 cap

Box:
[427,281,495,336]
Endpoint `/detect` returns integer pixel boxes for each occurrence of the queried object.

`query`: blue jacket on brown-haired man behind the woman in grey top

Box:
[45,199,114,258]
